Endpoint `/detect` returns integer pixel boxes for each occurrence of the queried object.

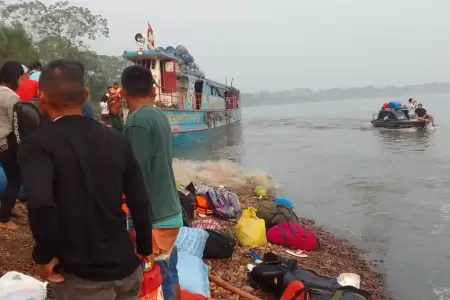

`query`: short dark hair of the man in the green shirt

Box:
[122,65,154,97]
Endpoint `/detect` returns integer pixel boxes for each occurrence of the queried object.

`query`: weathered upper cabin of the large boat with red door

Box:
[119,47,240,110]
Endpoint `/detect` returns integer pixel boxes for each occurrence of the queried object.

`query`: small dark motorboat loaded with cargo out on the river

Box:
[371,108,431,129]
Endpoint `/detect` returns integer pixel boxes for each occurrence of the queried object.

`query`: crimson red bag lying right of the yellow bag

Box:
[267,222,319,251]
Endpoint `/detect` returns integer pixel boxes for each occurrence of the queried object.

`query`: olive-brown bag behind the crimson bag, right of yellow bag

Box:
[255,202,300,229]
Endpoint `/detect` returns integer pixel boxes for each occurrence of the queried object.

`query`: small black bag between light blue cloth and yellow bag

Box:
[203,229,236,259]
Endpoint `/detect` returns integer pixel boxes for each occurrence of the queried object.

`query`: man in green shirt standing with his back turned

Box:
[122,65,183,300]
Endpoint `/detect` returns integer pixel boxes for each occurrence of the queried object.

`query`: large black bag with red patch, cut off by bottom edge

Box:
[282,268,370,300]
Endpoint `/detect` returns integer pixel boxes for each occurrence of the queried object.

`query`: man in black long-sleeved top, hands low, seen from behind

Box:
[18,60,152,300]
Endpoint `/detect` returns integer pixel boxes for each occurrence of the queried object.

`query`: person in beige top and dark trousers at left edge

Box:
[0,61,25,230]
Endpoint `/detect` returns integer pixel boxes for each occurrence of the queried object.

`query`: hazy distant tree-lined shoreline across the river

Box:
[241,83,450,107]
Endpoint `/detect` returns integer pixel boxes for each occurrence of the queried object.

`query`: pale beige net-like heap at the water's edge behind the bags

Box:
[173,159,280,191]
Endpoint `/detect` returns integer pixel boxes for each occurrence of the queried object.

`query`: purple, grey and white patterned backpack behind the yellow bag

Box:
[206,187,241,218]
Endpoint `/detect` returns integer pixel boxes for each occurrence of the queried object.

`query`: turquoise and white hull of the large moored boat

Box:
[164,108,241,147]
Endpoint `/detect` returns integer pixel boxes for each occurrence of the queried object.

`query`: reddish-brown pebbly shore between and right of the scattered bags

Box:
[206,190,393,300]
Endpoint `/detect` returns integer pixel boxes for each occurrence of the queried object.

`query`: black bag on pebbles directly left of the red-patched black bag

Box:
[248,252,297,297]
